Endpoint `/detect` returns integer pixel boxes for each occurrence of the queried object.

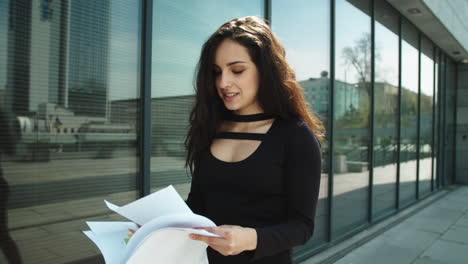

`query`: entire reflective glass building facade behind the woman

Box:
[0,0,457,264]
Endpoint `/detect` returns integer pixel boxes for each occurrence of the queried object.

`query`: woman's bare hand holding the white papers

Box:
[190,225,257,256]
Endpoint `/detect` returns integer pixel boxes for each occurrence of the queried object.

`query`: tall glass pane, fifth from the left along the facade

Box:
[372,1,399,217]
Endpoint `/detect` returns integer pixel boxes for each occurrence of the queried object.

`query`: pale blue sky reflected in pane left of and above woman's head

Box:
[152,0,264,97]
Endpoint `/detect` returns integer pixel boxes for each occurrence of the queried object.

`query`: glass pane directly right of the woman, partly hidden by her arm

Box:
[272,0,330,251]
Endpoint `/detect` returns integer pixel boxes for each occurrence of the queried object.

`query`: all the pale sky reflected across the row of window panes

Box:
[0,0,436,100]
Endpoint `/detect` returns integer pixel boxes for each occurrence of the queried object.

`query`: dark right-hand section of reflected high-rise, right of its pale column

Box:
[68,0,110,116]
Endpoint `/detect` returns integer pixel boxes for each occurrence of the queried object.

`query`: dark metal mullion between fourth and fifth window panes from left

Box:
[368,0,375,223]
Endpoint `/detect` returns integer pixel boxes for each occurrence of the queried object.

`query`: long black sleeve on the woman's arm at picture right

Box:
[251,121,321,261]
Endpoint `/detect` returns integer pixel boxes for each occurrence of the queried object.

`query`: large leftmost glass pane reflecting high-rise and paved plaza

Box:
[0,0,140,263]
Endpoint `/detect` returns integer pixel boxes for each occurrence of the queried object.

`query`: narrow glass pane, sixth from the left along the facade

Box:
[400,21,419,206]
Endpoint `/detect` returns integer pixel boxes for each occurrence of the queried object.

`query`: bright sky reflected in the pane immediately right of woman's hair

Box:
[272,0,330,81]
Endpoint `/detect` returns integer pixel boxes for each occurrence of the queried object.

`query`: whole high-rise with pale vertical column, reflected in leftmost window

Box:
[5,0,110,117]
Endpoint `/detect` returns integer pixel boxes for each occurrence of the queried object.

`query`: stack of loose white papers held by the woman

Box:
[84,185,217,264]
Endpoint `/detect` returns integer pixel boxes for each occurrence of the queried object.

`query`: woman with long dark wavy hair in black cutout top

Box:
[186,17,324,264]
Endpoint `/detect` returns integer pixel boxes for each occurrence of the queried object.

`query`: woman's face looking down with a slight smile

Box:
[214,39,263,115]
